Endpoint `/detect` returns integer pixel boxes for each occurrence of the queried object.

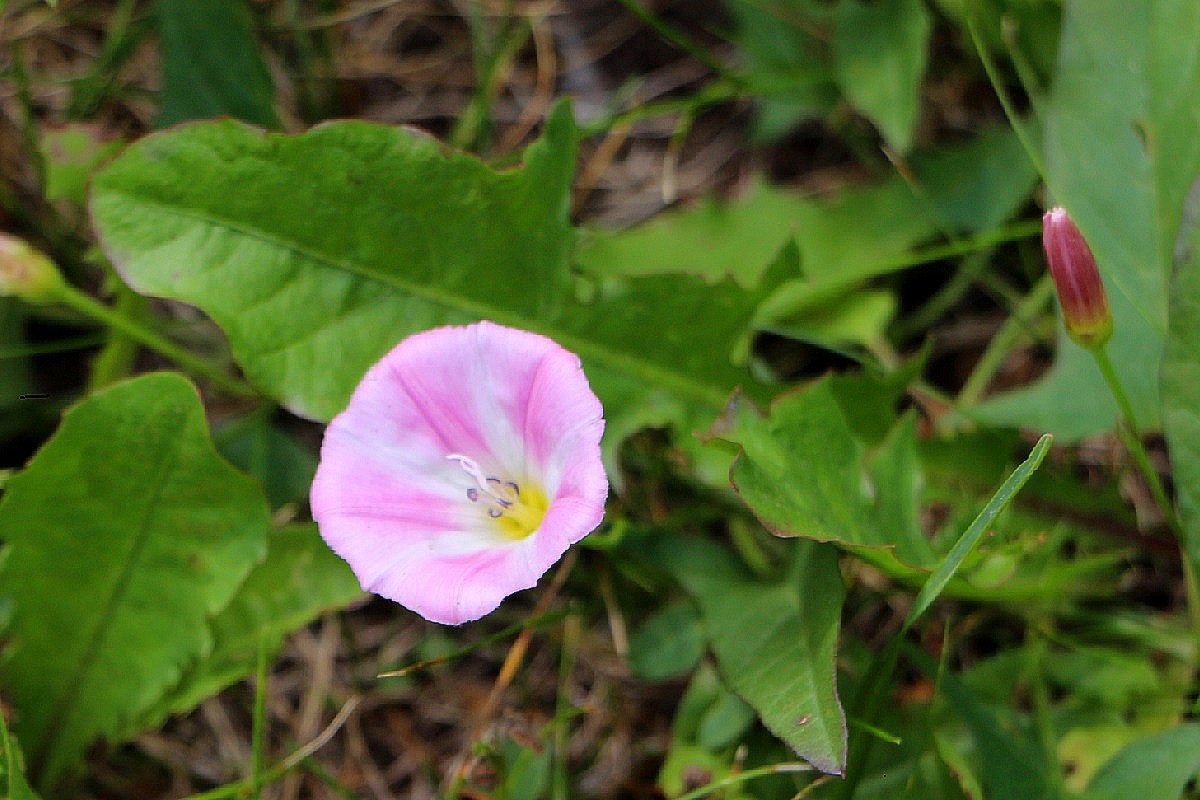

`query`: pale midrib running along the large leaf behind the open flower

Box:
[108,190,733,410]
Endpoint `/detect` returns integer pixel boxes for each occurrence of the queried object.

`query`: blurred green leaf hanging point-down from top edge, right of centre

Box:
[834,0,932,152]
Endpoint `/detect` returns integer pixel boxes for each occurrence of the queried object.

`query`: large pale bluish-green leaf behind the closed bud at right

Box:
[979,0,1200,440]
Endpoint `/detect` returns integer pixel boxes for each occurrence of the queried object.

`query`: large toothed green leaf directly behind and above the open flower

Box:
[91,104,786,439]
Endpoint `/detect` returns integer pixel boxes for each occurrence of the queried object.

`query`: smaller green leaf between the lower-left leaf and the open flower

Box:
[140,524,364,727]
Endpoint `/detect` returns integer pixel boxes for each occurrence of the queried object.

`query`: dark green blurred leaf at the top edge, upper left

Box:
[155,0,280,128]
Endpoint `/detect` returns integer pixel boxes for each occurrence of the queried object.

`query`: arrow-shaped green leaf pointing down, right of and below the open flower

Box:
[652,536,846,774]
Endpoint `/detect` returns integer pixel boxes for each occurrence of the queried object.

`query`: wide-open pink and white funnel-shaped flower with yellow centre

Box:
[312,321,608,625]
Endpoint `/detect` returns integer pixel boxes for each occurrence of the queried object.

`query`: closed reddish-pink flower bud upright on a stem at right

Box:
[1042,207,1112,348]
